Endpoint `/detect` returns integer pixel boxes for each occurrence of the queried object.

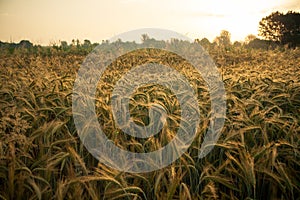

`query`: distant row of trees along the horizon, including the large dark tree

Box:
[0,11,300,54]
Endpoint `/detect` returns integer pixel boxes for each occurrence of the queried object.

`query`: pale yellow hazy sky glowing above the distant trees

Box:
[0,0,300,44]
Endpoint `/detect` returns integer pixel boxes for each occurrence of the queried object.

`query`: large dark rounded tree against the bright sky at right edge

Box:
[259,11,300,46]
